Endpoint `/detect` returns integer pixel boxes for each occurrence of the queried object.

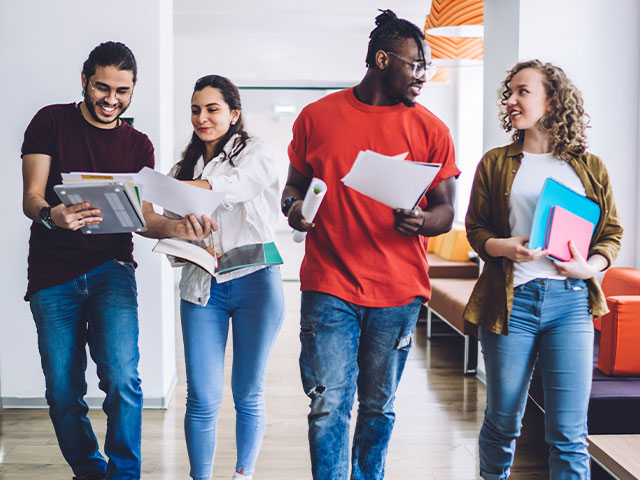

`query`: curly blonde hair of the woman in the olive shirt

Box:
[499,59,589,160]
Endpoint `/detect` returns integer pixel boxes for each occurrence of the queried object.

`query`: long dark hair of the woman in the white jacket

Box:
[176,75,249,180]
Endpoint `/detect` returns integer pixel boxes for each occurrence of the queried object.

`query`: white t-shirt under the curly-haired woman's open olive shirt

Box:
[509,152,585,287]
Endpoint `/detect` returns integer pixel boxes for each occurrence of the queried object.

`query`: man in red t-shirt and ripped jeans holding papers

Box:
[282,10,460,480]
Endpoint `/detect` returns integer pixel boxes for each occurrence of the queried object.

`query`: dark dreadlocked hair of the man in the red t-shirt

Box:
[365,10,425,68]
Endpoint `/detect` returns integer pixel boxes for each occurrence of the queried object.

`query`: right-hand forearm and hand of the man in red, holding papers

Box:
[393,177,456,237]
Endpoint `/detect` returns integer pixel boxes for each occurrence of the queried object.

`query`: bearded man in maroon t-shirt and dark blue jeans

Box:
[22,42,211,480]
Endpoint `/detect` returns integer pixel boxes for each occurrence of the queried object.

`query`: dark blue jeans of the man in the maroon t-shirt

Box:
[29,260,142,479]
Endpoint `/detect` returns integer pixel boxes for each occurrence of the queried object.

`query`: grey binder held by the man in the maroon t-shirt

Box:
[53,181,147,235]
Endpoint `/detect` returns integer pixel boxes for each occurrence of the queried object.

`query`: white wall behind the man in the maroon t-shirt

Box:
[0,0,176,408]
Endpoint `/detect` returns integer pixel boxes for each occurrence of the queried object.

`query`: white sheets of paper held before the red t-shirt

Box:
[342,150,442,209]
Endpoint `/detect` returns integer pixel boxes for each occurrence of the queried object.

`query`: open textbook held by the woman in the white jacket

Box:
[153,238,282,277]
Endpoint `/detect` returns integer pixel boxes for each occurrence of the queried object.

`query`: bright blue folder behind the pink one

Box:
[529,177,600,248]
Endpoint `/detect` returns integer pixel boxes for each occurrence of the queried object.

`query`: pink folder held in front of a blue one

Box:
[544,205,593,262]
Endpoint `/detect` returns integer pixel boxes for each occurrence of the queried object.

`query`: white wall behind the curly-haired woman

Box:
[484,0,640,266]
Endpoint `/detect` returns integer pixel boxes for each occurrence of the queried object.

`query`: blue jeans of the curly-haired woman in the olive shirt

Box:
[479,279,593,480]
